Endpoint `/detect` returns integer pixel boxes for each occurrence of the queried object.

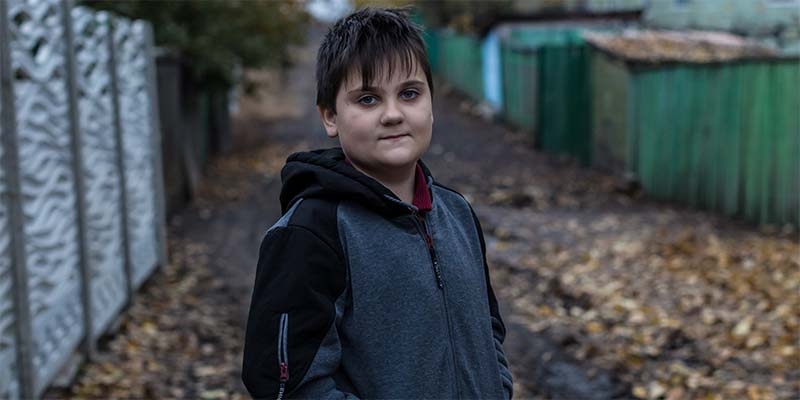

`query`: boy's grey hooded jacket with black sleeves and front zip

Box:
[242,149,512,399]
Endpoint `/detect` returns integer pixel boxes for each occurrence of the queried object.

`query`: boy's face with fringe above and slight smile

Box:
[319,59,433,177]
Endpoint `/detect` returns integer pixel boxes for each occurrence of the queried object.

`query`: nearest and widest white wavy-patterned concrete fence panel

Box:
[7,0,84,391]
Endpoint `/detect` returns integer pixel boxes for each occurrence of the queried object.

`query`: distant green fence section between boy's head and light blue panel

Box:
[435,32,483,101]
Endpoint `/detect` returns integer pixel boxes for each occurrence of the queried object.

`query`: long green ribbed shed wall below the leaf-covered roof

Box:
[593,54,800,226]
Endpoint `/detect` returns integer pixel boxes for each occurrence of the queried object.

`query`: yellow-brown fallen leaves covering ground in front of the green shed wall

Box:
[479,207,800,399]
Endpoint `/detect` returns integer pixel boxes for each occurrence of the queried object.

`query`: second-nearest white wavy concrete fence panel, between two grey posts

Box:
[72,7,127,337]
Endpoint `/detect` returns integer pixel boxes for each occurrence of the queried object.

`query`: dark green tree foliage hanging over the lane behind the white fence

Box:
[81,0,309,88]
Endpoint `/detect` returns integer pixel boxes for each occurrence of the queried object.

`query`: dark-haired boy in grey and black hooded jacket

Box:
[242,9,512,399]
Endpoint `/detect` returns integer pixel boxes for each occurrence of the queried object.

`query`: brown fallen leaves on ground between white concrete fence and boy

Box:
[44,139,303,400]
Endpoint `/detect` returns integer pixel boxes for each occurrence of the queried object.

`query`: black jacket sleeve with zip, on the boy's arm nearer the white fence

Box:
[242,225,350,398]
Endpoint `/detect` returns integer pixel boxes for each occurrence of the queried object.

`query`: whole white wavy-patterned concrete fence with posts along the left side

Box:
[0,0,165,399]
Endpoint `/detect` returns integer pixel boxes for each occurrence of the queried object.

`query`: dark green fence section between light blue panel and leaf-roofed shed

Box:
[500,27,591,165]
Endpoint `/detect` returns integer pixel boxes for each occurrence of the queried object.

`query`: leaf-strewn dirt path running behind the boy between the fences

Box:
[53,22,800,399]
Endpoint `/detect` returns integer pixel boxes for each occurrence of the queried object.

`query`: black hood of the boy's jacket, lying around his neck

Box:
[280,147,432,216]
